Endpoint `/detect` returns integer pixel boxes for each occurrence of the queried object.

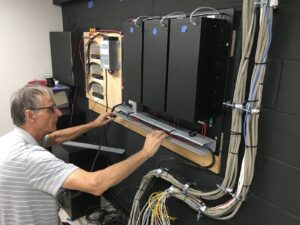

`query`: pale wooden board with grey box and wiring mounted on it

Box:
[83,31,122,108]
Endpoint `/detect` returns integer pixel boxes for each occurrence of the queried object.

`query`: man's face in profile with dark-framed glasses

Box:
[34,95,62,135]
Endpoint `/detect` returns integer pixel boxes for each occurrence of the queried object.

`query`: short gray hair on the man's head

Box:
[10,84,53,127]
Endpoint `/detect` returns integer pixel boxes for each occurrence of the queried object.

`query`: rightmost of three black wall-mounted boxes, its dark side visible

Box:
[165,17,230,122]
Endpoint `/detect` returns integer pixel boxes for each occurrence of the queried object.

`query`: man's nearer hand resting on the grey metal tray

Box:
[142,130,167,158]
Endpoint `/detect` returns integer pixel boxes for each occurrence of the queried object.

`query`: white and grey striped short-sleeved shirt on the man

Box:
[0,127,78,225]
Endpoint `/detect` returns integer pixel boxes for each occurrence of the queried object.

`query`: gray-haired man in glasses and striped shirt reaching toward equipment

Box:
[0,85,166,225]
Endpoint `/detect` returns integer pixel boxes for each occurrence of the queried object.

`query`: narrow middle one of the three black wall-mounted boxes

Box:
[142,20,169,112]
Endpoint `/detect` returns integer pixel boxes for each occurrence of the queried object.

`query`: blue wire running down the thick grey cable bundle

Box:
[243,6,272,145]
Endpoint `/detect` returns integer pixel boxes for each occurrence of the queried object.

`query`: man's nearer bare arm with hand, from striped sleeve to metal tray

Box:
[63,131,166,195]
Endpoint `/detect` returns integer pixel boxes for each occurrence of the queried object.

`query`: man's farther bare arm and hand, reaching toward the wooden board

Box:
[44,112,112,147]
